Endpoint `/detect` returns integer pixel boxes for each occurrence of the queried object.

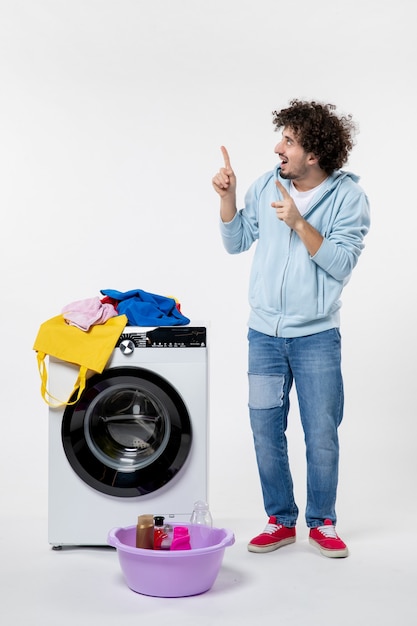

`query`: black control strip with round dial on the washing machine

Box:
[116,326,207,348]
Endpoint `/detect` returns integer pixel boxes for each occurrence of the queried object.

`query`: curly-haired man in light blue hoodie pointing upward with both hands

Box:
[212,100,369,557]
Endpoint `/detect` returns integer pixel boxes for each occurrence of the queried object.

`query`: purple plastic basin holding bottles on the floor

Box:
[107,524,235,598]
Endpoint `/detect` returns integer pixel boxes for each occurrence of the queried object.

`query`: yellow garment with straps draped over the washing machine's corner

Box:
[33,315,127,407]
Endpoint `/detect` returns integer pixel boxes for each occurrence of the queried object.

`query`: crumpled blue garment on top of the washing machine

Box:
[101,289,190,326]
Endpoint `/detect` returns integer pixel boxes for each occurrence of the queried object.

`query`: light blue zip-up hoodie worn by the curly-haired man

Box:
[220,165,370,337]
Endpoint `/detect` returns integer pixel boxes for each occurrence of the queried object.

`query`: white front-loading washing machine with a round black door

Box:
[48,325,208,547]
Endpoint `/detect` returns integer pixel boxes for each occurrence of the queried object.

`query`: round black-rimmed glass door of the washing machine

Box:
[62,367,192,497]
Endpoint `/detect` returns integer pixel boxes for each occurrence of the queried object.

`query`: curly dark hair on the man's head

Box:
[272,99,358,174]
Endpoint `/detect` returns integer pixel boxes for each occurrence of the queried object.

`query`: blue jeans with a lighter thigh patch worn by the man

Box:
[248,328,344,528]
